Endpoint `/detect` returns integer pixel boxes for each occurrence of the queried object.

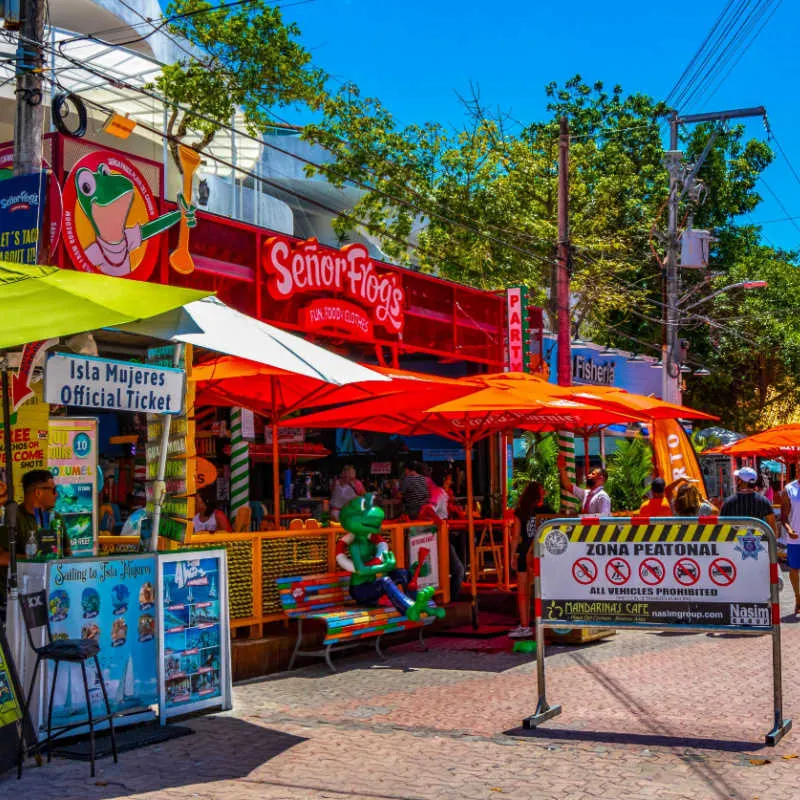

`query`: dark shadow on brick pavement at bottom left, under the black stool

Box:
[0,715,307,800]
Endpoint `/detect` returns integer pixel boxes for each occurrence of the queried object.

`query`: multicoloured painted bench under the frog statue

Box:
[277,572,434,672]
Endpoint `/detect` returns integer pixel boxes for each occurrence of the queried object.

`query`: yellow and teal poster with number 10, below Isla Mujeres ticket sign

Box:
[47,417,98,556]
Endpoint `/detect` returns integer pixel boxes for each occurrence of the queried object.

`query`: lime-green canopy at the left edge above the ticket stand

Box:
[0,261,209,349]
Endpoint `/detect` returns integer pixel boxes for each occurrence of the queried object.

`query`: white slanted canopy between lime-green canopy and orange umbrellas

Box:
[115,297,389,390]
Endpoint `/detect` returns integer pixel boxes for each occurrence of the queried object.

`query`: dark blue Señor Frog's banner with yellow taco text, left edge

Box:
[0,172,47,264]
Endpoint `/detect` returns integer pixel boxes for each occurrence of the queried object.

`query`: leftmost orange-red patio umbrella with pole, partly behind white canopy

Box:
[192,360,465,527]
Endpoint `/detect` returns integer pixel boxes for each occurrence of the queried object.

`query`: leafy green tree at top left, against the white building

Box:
[155,0,325,165]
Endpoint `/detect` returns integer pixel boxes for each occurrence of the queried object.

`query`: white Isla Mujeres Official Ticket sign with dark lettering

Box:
[44,353,186,414]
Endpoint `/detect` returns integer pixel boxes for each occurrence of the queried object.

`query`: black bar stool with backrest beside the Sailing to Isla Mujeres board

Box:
[17,590,117,778]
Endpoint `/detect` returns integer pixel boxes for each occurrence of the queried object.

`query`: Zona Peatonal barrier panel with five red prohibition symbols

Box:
[537,518,775,631]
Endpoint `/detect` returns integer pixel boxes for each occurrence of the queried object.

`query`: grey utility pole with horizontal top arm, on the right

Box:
[661,106,767,403]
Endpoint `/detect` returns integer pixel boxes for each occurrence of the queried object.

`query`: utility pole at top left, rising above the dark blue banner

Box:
[14,0,46,175]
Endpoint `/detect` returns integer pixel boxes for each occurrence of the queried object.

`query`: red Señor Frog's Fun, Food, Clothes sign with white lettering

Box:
[263,236,405,338]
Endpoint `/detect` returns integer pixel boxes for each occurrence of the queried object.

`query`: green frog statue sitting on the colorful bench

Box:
[336,494,445,622]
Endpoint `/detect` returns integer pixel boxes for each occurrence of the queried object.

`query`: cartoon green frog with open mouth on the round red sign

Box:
[75,164,197,277]
